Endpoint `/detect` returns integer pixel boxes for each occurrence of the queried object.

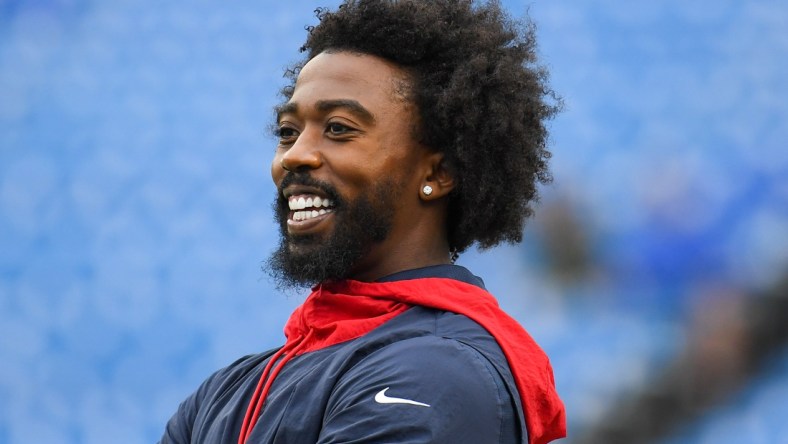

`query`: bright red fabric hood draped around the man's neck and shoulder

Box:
[285,278,566,444]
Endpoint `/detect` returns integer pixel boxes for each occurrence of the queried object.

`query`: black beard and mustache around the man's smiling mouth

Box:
[266,173,399,289]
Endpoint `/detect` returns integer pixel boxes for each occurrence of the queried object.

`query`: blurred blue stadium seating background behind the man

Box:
[0,0,788,444]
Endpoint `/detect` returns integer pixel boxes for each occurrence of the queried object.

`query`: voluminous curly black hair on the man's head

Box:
[283,0,561,254]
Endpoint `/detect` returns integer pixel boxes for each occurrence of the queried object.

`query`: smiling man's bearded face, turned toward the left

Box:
[270,52,426,285]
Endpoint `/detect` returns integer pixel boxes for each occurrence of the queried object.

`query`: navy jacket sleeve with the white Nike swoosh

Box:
[318,336,520,444]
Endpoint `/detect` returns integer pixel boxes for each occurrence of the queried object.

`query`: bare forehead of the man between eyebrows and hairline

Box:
[285,52,409,114]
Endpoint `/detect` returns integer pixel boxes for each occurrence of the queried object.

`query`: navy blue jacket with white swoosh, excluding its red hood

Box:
[160,266,526,444]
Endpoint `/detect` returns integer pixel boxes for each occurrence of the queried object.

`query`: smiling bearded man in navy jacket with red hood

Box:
[162,0,565,444]
